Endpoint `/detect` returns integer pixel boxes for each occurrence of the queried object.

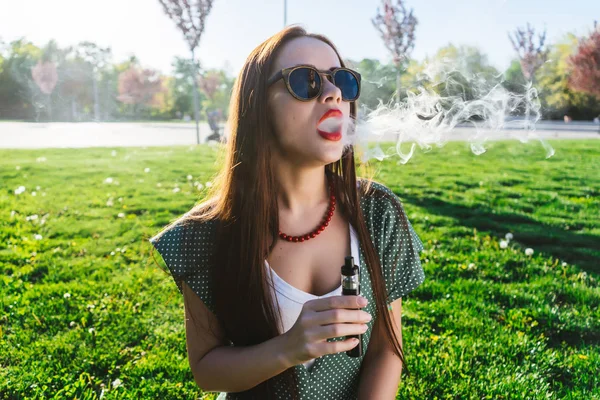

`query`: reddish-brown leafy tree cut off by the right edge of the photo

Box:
[569,29,600,100]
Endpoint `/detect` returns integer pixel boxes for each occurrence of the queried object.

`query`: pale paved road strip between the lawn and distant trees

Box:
[0,122,600,149]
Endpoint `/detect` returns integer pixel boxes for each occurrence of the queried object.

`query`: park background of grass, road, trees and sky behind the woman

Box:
[0,0,600,400]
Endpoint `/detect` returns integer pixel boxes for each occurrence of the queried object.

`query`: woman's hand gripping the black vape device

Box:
[283,295,371,365]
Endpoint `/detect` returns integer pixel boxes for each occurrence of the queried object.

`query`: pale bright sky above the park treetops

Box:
[0,0,600,74]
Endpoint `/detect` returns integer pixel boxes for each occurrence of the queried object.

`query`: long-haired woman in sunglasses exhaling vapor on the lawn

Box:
[151,27,424,399]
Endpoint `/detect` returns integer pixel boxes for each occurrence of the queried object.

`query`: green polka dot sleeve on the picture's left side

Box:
[150,222,215,314]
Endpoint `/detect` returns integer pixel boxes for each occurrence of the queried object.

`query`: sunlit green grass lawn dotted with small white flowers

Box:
[0,141,600,399]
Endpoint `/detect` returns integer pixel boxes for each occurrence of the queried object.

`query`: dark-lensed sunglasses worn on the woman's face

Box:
[267,65,360,101]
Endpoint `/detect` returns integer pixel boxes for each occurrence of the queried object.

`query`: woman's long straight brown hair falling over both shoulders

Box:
[184,26,408,399]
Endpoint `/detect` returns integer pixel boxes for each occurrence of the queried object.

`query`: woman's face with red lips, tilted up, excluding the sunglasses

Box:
[268,37,350,166]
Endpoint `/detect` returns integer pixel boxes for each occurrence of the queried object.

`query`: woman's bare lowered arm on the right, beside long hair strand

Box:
[358,298,402,400]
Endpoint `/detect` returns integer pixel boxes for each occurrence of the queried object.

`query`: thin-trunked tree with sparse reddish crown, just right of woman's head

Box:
[372,0,418,102]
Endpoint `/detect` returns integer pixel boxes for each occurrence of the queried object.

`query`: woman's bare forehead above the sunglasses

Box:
[273,37,341,71]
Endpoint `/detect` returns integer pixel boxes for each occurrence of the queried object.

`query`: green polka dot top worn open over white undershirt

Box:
[150,183,425,400]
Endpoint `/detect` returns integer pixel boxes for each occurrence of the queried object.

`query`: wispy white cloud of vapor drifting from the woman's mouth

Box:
[344,60,554,164]
